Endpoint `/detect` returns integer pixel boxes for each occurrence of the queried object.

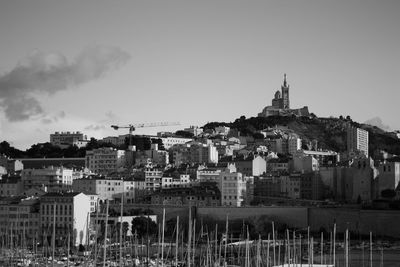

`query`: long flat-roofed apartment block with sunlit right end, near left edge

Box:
[21,167,75,191]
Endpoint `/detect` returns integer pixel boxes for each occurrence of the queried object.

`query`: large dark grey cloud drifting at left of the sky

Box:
[0,46,130,121]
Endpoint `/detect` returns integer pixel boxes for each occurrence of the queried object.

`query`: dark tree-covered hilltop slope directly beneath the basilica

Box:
[203,114,400,155]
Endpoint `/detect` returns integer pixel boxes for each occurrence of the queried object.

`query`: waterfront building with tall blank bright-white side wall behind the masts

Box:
[40,192,90,246]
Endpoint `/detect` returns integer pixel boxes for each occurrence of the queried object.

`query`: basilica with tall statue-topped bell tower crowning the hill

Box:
[258,74,310,117]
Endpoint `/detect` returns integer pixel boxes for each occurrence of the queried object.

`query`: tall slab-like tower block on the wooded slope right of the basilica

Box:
[347,126,368,157]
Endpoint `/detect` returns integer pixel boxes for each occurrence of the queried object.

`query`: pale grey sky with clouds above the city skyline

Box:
[0,0,400,149]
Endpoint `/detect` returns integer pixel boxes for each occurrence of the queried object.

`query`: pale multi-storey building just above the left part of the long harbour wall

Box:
[219,171,247,207]
